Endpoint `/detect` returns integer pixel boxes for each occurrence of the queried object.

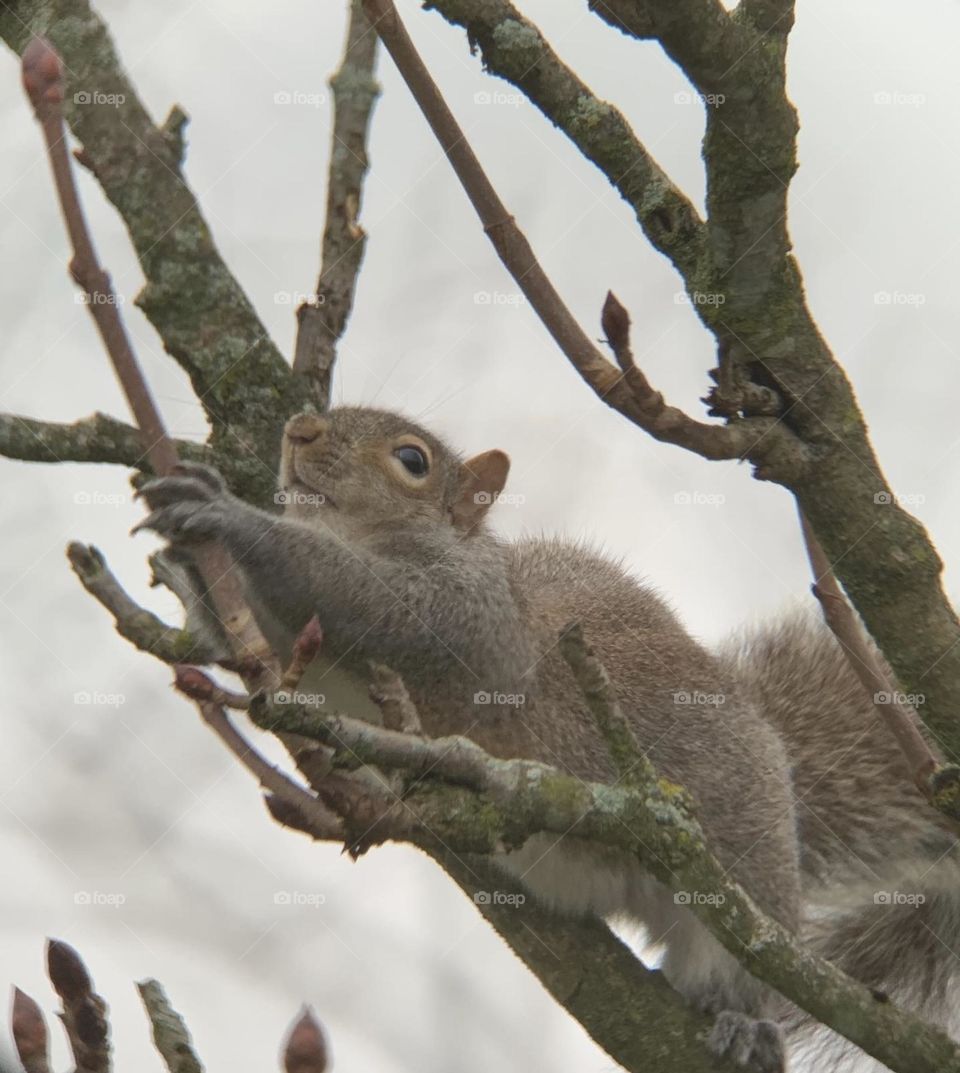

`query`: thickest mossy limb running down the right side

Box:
[422,0,960,763]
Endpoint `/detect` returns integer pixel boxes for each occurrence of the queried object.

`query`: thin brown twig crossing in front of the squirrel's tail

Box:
[798,508,940,792]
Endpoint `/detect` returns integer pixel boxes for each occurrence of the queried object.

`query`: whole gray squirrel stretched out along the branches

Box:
[138,408,960,1073]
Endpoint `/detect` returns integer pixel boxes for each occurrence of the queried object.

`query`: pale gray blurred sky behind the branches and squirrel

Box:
[0,0,960,1073]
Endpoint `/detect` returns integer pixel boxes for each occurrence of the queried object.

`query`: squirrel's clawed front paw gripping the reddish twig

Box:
[131,462,236,544]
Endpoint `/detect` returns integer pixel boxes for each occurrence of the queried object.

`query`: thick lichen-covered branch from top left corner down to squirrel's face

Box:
[0,0,297,490]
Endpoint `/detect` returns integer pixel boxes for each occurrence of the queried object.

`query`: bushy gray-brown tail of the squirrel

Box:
[721,613,960,1055]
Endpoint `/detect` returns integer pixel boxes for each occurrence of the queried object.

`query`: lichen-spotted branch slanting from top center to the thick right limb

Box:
[424,0,705,277]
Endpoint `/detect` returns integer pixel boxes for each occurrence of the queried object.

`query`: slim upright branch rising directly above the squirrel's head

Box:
[293,0,380,410]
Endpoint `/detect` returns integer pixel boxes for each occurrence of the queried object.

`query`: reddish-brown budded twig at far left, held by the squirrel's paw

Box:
[23,38,279,688]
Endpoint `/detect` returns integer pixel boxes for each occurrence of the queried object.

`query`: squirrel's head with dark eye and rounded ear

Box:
[280,407,509,537]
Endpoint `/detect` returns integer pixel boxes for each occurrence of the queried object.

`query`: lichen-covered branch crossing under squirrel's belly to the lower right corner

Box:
[250,694,960,1073]
